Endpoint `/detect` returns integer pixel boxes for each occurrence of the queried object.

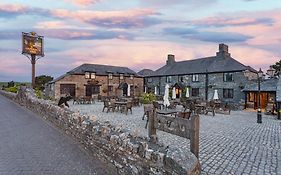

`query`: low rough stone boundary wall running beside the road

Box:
[0,87,200,175]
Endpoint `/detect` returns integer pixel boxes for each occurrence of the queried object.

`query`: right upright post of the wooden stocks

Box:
[190,115,200,158]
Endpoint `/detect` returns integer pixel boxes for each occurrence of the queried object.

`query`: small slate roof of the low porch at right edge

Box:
[243,78,278,92]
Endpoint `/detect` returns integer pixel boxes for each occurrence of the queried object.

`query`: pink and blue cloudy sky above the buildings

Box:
[0,0,281,82]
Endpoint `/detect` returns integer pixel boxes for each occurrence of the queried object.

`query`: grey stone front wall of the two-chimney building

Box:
[145,71,246,109]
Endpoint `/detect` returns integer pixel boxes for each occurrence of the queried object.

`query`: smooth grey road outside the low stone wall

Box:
[0,95,116,175]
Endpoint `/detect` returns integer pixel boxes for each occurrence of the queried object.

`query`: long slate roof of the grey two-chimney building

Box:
[147,55,249,76]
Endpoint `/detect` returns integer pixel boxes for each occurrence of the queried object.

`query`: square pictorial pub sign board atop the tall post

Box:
[22,32,44,57]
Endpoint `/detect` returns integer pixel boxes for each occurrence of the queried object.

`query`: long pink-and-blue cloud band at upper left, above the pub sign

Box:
[0,5,162,28]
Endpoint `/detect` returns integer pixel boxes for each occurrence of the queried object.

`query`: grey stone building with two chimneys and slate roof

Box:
[139,44,257,104]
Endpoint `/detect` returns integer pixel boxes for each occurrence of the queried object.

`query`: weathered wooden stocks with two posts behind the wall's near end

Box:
[148,109,199,158]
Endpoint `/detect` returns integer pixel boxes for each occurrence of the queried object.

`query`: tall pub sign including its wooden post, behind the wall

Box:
[22,32,44,88]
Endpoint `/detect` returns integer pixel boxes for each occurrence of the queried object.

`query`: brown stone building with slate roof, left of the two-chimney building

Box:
[46,64,143,99]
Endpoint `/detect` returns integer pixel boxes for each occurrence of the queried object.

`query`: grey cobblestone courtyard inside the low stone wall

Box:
[71,102,281,175]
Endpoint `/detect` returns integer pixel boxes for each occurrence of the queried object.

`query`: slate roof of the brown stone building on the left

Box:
[67,64,138,76]
